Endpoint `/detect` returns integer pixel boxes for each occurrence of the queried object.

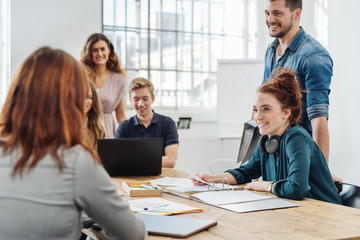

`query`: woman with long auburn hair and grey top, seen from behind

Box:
[0,47,146,240]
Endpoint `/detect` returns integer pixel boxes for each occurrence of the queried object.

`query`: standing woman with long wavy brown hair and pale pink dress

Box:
[81,33,127,138]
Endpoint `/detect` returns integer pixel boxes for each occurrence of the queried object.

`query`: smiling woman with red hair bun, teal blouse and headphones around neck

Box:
[193,68,341,204]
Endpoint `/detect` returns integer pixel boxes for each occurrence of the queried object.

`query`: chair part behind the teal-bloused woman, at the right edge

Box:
[335,182,360,209]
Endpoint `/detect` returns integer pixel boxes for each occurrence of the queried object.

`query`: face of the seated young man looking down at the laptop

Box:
[130,87,155,118]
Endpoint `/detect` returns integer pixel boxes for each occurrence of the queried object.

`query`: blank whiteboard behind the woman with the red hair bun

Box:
[217,59,264,138]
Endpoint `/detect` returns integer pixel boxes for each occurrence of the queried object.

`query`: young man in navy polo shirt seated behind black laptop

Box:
[115,78,179,168]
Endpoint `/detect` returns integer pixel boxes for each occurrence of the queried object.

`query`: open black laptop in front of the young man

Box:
[97,138,163,177]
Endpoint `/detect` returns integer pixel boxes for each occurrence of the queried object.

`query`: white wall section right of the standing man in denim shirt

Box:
[329,0,360,185]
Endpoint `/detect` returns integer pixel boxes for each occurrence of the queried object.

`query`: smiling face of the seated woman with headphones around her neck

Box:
[253,93,291,137]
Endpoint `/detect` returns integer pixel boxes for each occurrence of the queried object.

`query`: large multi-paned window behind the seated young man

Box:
[103,0,257,110]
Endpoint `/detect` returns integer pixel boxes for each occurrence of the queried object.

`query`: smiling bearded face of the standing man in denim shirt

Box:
[265,0,301,38]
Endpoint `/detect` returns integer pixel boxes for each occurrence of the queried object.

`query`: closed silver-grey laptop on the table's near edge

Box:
[136,213,217,238]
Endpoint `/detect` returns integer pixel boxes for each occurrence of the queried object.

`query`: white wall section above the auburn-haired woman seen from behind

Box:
[10,0,102,76]
